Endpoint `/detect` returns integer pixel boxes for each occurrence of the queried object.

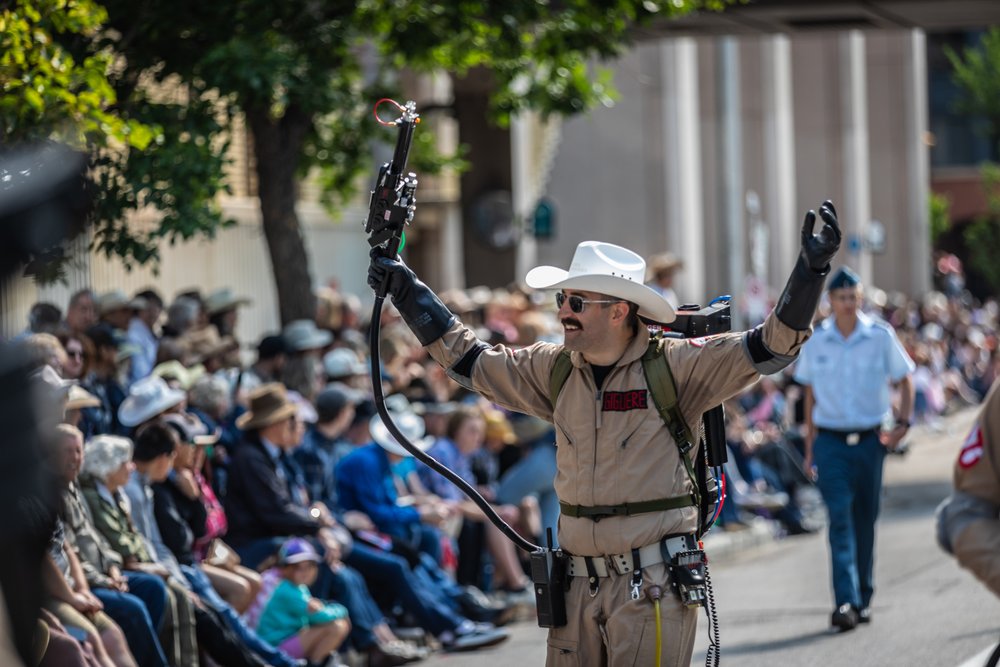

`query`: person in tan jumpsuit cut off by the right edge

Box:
[938,382,1000,596]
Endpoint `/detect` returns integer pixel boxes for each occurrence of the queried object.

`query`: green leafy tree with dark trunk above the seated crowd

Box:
[0,0,729,320]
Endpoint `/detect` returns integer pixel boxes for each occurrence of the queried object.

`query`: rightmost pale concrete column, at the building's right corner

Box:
[900,30,933,296]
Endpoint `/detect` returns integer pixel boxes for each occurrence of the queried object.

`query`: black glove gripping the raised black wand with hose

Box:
[368,248,455,345]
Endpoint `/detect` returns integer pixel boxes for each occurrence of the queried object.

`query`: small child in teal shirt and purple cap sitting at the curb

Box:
[257,538,351,665]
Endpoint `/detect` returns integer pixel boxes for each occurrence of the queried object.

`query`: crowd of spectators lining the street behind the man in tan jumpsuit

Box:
[16,252,1000,667]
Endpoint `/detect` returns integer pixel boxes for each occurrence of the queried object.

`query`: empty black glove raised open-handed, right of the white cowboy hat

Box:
[774,200,841,331]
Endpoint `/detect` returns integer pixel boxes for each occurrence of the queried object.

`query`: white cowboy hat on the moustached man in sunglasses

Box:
[524,241,675,324]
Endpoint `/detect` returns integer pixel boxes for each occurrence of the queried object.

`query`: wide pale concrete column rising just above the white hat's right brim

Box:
[660,37,708,303]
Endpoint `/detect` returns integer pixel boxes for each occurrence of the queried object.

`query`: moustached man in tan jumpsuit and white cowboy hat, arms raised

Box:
[369,202,840,666]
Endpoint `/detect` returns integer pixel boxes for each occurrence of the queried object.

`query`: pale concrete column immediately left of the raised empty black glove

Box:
[761,35,802,290]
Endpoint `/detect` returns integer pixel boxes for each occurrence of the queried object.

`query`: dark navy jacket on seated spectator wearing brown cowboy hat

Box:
[223,434,320,546]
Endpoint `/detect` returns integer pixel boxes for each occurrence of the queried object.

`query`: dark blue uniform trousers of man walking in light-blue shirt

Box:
[813,430,885,609]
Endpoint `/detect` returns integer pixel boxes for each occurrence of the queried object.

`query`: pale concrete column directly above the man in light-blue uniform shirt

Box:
[840,30,872,283]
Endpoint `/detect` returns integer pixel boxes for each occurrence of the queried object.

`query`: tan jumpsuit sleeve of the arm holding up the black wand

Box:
[427,320,562,422]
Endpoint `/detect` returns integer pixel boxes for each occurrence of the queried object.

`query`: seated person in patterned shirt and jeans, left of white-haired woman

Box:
[59,424,167,667]
